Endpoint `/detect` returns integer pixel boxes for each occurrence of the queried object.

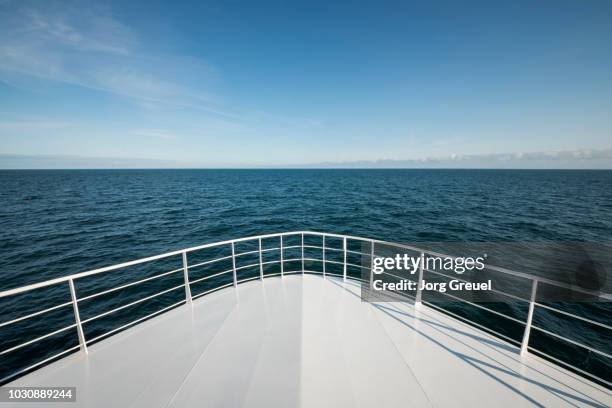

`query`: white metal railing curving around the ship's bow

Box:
[0,231,612,387]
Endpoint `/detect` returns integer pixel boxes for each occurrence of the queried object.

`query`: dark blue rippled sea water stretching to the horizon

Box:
[0,169,612,386]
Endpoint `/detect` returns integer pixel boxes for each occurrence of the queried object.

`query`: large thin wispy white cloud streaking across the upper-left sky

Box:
[0,0,330,145]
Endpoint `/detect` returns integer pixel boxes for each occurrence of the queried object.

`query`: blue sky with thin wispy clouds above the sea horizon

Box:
[0,0,612,168]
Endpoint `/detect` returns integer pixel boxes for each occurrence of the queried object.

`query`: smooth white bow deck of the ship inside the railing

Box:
[5,275,612,408]
